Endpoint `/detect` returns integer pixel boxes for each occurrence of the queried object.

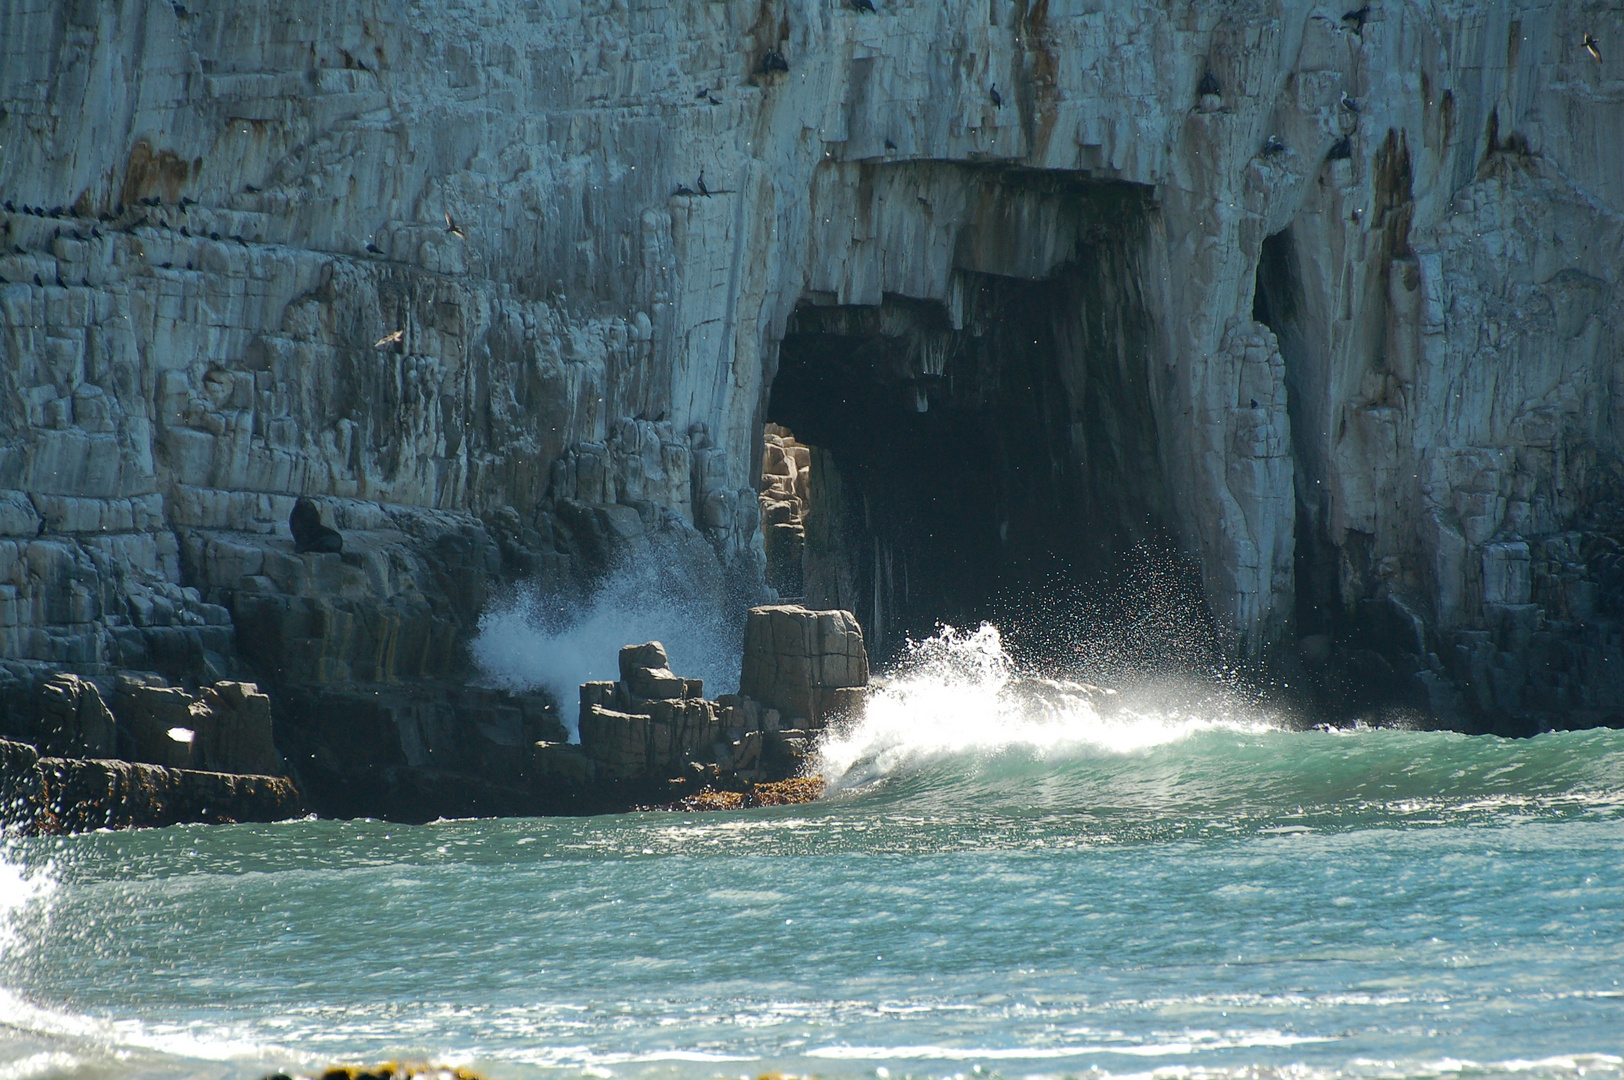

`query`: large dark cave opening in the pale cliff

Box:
[763,267,1166,659]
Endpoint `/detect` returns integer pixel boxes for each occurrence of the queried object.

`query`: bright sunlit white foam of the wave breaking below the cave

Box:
[820,624,1272,789]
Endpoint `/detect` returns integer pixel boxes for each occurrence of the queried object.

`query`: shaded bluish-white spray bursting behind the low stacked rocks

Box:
[471,552,744,742]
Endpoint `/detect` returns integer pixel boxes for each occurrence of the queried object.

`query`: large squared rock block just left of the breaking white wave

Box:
[739,606,869,728]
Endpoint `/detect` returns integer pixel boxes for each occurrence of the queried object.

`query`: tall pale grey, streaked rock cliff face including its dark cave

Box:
[0,0,1624,726]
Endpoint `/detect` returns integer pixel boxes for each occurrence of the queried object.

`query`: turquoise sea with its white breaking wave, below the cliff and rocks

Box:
[0,623,1624,1080]
